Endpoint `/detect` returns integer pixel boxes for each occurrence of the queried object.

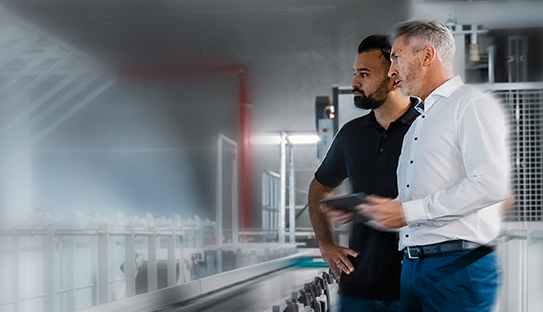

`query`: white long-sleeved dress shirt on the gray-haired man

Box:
[397,76,509,250]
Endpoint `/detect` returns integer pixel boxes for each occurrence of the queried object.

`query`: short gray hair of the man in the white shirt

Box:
[392,20,456,69]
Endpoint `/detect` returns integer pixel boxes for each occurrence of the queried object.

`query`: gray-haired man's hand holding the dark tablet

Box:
[355,195,407,230]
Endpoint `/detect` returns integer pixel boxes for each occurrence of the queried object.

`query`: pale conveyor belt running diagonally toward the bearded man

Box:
[157,267,326,312]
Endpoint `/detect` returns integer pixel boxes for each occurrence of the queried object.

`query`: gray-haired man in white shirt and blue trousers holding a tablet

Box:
[358,20,509,312]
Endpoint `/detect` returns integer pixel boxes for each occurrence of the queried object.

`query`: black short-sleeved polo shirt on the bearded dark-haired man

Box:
[315,99,419,301]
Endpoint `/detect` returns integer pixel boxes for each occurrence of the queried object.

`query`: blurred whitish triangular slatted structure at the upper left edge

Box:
[0,7,116,169]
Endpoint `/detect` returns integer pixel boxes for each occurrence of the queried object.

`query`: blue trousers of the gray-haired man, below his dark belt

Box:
[401,247,498,312]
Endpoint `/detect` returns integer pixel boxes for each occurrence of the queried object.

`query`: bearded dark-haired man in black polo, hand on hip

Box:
[309,35,418,311]
